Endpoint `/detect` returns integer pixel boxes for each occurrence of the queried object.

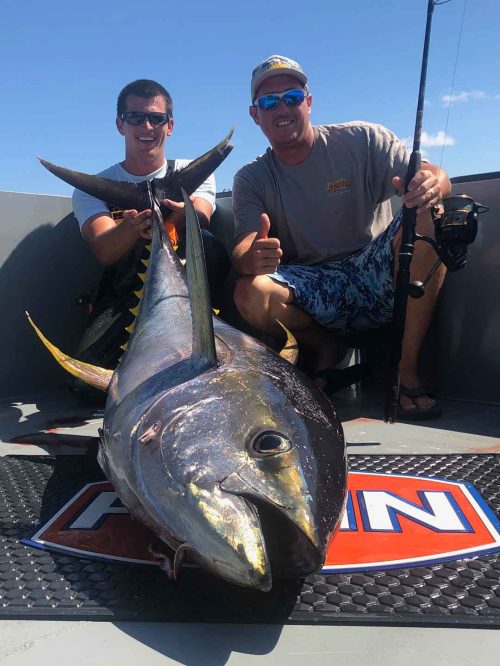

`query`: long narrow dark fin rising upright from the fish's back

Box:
[182,189,217,367]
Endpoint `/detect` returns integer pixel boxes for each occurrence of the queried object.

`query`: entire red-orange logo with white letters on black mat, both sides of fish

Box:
[24,472,500,573]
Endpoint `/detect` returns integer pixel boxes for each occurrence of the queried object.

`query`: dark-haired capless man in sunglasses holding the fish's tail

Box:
[69,79,230,397]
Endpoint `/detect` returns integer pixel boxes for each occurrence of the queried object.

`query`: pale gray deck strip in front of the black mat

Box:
[0,621,500,666]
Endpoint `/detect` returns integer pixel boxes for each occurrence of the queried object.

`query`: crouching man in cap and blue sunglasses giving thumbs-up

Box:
[233,55,451,419]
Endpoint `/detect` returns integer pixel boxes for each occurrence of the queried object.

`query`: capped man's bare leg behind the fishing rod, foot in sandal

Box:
[393,213,446,410]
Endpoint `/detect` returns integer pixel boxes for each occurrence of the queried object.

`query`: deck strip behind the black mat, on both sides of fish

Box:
[0,387,500,456]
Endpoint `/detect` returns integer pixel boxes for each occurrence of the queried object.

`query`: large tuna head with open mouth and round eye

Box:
[123,352,346,590]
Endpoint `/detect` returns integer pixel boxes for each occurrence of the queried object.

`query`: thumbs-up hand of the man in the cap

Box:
[232,213,283,275]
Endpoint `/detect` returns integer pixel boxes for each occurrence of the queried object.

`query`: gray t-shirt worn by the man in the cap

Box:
[233,121,409,265]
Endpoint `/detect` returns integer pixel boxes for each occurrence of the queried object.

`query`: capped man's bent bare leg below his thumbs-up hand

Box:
[234,275,345,373]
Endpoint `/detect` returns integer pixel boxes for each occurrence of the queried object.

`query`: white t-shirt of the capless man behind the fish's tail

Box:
[73,160,215,229]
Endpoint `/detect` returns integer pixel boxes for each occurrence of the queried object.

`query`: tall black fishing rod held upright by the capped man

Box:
[384,0,450,423]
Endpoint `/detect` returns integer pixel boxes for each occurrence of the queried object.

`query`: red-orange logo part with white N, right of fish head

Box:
[323,472,500,573]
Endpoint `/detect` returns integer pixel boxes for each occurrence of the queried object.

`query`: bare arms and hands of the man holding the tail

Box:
[82,198,212,266]
